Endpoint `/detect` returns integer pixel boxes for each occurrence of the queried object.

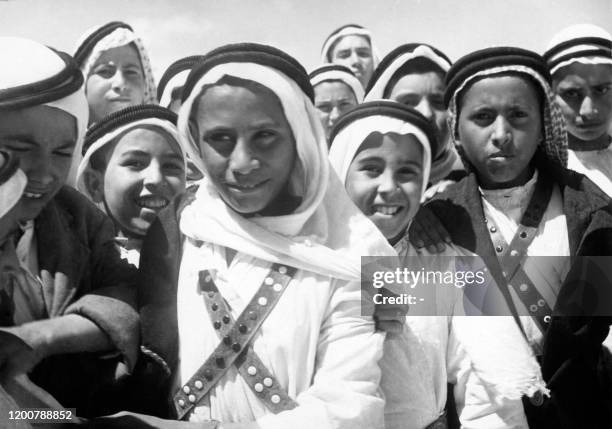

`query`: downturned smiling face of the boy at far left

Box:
[0,106,77,220]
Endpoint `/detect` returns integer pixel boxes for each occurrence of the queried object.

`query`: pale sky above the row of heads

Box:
[0,0,612,80]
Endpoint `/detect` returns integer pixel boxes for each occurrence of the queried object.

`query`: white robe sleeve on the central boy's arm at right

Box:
[256,281,384,429]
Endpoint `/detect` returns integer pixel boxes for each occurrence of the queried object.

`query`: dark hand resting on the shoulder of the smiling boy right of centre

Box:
[408,206,452,253]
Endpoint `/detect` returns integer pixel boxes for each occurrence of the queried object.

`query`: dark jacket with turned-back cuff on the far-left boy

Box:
[23,187,139,415]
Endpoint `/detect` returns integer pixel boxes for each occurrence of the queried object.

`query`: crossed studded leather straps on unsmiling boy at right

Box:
[487,176,553,332]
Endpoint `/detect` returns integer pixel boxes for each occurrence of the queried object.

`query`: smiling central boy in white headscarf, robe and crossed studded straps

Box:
[92,44,394,429]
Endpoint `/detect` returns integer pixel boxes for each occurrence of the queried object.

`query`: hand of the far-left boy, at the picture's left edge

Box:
[0,325,45,383]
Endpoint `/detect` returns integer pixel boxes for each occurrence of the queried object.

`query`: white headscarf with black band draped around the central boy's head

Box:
[178,43,394,280]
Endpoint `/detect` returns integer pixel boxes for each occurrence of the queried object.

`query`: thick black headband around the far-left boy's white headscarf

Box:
[0,48,83,110]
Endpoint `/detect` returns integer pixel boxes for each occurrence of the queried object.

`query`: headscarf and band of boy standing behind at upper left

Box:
[74,21,157,104]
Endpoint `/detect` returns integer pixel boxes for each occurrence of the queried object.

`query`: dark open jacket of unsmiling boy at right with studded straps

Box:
[426,160,612,428]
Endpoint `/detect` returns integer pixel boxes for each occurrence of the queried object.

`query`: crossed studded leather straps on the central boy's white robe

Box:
[173,264,297,419]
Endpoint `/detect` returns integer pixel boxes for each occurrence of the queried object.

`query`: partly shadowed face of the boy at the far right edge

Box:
[553,63,612,141]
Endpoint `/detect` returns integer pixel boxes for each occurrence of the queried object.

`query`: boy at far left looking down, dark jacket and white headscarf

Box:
[0,37,138,412]
